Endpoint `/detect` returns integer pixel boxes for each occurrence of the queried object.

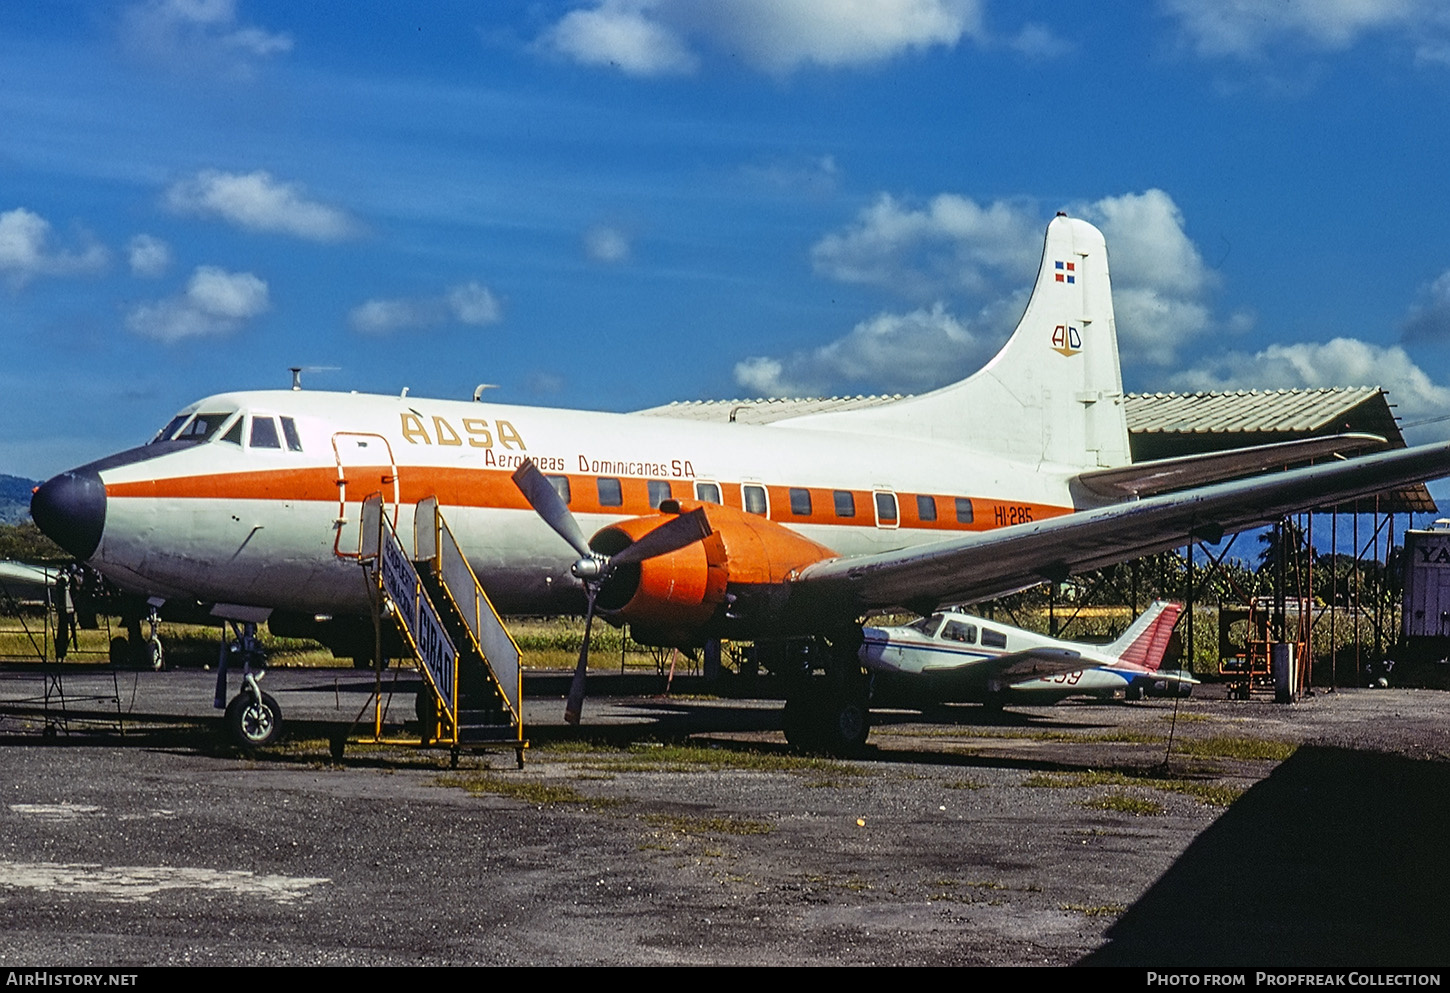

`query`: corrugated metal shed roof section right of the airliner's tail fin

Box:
[1124,386,1380,435]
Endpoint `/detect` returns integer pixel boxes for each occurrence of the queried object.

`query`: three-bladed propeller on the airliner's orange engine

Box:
[513,461,711,725]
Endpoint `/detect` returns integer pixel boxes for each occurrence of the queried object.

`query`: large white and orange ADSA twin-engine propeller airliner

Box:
[30,215,1450,751]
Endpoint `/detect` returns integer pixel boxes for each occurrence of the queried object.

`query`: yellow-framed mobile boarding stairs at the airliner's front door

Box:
[360,494,528,768]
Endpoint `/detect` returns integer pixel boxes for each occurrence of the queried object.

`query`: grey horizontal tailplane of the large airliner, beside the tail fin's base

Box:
[1077,433,1386,500]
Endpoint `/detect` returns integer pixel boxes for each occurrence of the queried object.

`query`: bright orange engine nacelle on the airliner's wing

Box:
[589,500,835,639]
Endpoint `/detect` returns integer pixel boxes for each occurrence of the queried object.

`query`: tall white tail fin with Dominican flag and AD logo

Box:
[777,215,1132,470]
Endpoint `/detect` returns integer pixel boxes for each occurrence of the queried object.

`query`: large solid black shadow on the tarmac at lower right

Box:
[1080,747,1450,967]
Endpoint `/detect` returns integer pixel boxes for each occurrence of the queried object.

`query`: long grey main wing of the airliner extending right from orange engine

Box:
[787,442,1450,623]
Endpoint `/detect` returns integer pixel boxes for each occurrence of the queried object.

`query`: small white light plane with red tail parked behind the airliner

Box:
[861,600,1198,707]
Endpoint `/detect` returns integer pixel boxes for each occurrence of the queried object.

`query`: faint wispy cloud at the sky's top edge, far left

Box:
[122,0,293,75]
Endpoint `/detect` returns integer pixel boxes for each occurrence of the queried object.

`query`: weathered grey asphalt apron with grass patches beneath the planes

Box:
[0,667,1450,968]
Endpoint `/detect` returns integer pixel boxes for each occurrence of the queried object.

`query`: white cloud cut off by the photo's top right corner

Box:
[1161,0,1450,59]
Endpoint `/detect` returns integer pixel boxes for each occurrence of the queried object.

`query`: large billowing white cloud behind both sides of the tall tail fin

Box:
[735,190,1235,396]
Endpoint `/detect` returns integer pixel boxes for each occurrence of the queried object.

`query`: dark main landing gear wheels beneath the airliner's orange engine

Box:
[783,628,871,757]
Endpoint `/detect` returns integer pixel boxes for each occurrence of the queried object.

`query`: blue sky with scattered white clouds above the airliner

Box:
[8,0,1450,478]
